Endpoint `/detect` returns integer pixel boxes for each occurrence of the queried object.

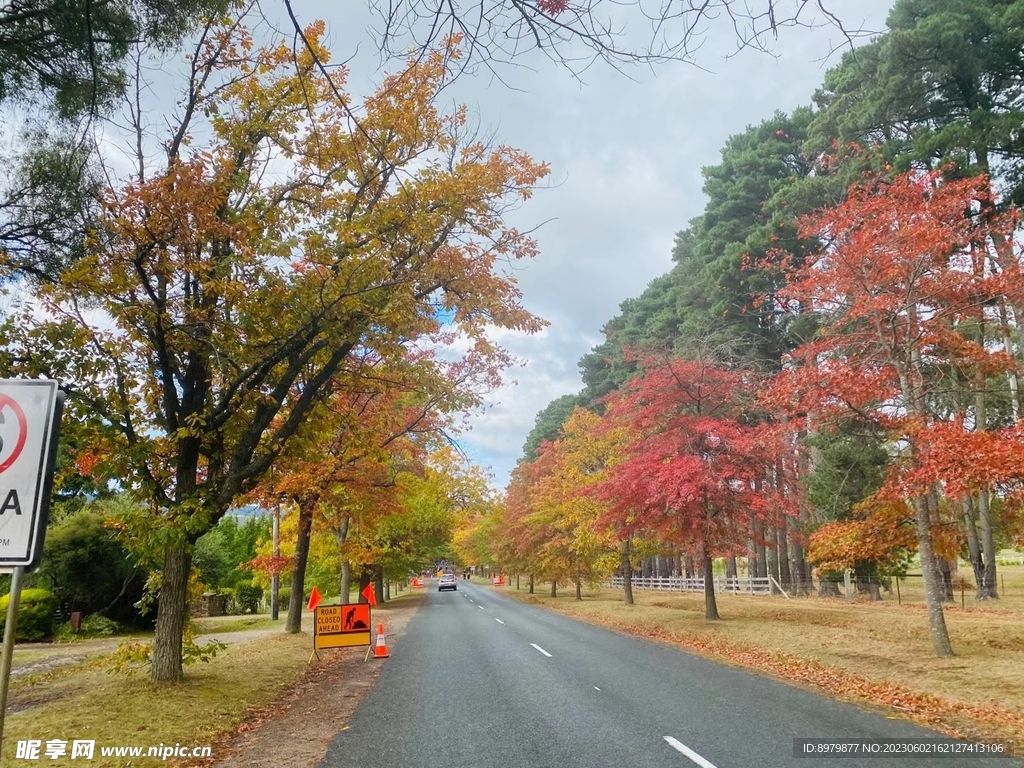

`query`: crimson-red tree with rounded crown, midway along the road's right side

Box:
[595,355,785,620]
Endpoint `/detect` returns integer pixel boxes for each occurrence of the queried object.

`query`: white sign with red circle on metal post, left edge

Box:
[0,379,65,761]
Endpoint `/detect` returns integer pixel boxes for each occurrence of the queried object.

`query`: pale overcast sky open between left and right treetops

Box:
[276,0,892,488]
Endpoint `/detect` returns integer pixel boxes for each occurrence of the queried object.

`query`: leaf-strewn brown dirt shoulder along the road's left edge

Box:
[207,593,425,768]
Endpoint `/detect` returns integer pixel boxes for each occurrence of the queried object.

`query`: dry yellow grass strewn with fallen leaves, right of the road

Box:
[499,566,1024,739]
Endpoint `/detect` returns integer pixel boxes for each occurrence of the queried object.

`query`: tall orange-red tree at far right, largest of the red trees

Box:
[774,172,1021,656]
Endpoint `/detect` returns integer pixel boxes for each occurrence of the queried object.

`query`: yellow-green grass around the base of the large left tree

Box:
[4,634,311,766]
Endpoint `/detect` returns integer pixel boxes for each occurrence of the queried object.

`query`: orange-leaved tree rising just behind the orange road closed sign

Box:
[256,344,497,632]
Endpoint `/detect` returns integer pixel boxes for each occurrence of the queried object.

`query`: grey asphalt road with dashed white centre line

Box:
[321,580,1024,768]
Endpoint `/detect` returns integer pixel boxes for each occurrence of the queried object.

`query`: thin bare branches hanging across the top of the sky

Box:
[360,0,871,76]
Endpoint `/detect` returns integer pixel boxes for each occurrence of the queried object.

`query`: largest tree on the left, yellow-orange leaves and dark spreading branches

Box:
[2,18,548,682]
